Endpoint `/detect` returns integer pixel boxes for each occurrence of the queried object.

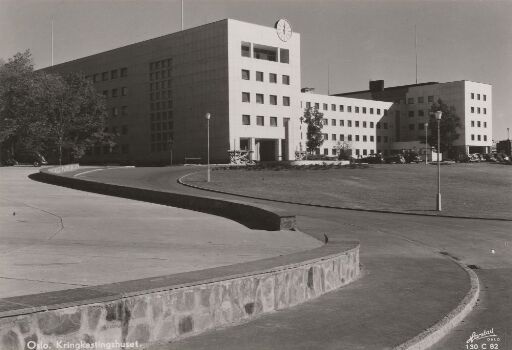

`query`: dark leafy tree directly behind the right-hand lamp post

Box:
[427,99,460,157]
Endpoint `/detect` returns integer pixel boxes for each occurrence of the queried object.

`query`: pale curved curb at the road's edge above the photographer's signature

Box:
[394,258,480,350]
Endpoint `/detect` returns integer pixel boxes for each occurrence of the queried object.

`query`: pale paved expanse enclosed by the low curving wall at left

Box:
[0,167,321,298]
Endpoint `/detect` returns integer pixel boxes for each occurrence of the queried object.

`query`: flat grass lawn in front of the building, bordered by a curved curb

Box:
[185,163,512,219]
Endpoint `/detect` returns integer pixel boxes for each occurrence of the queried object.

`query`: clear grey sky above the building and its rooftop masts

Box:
[0,0,512,140]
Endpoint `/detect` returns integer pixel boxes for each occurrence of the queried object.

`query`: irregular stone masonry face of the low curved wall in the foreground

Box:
[0,246,359,350]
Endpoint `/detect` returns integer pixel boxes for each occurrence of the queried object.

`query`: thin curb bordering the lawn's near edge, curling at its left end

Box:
[178,172,512,221]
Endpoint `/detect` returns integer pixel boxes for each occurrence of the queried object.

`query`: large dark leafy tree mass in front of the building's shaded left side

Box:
[0,51,114,163]
